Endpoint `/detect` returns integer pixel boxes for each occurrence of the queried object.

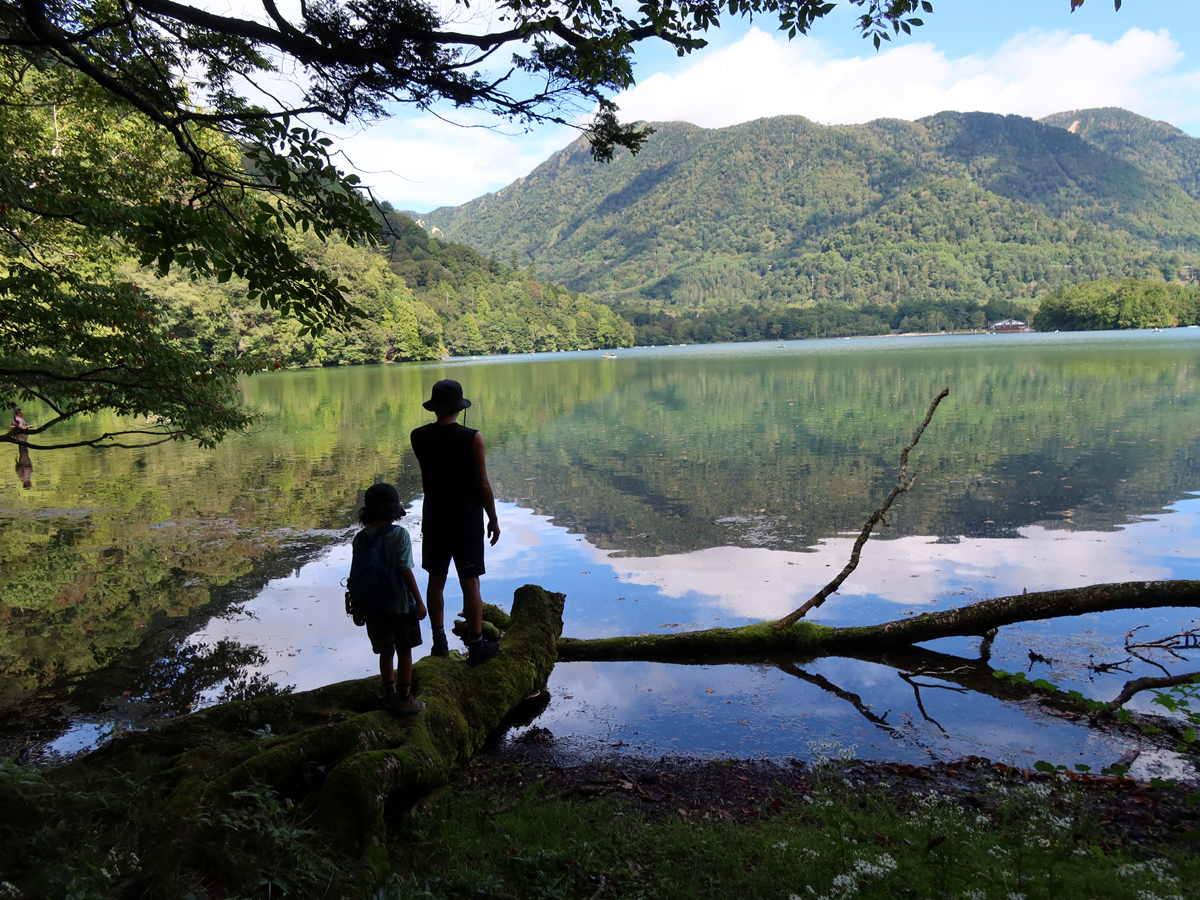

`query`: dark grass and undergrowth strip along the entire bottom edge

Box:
[0,762,1200,900]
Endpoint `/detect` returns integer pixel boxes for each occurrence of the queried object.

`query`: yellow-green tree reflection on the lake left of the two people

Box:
[0,369,419,707]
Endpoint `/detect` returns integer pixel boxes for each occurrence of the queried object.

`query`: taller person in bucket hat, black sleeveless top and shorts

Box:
[410,378,500,666]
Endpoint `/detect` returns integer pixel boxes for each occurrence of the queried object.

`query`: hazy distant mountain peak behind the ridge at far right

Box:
[1039,107,1200,198]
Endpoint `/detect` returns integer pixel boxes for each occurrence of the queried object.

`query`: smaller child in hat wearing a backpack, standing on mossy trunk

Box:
[347,482,426,715]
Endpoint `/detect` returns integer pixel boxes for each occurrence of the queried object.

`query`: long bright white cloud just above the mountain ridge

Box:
[609,28,1200,133]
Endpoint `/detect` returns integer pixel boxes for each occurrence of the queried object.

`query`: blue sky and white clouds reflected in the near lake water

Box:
[177,500,1200,770]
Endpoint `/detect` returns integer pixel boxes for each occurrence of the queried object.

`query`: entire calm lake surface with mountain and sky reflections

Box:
[0,329,1200,772]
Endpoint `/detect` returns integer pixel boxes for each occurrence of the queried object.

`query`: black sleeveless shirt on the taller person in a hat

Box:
[409,422,484,534]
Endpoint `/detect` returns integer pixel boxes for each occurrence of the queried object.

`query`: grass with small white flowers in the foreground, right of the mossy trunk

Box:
[376,775,1200,900]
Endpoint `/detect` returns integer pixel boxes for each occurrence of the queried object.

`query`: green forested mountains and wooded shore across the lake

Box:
[121,109,1200,367]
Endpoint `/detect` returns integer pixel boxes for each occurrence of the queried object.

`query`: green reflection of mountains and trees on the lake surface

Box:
[0,332,1200,707]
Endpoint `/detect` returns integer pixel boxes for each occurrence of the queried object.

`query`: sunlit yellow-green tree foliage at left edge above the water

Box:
[0,56,270,449]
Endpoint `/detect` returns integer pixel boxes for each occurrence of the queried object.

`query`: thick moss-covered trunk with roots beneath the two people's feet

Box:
[87,584,565,862]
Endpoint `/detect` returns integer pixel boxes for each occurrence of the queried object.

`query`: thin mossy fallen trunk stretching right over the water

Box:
[558,581,1200,661]
